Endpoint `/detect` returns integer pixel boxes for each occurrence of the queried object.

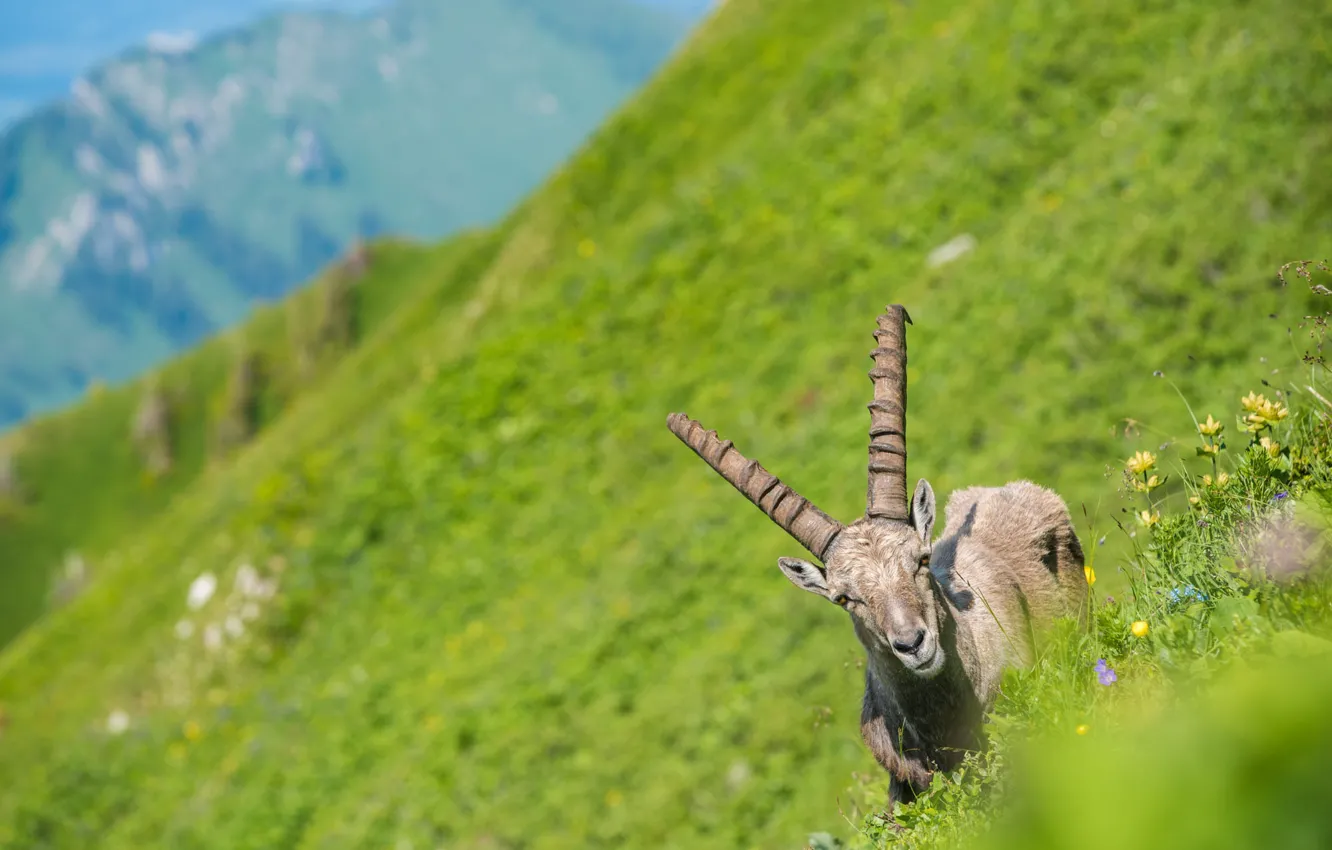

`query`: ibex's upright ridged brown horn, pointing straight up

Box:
[864,304,911,522]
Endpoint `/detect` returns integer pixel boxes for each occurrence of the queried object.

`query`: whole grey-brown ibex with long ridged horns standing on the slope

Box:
[667,305,1087,814]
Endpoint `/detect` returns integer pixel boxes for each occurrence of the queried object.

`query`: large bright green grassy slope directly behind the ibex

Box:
[0,0,1332,849]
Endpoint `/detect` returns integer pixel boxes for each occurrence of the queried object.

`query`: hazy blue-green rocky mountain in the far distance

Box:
[0,0,687,426]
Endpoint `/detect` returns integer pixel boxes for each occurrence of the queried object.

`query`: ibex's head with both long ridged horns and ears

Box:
[666,305,946,678]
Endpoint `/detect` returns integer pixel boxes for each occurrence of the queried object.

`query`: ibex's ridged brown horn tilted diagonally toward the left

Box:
[666,413,842,561]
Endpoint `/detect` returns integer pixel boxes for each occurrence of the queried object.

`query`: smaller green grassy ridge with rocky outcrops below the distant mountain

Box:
[0,233,498,643]
